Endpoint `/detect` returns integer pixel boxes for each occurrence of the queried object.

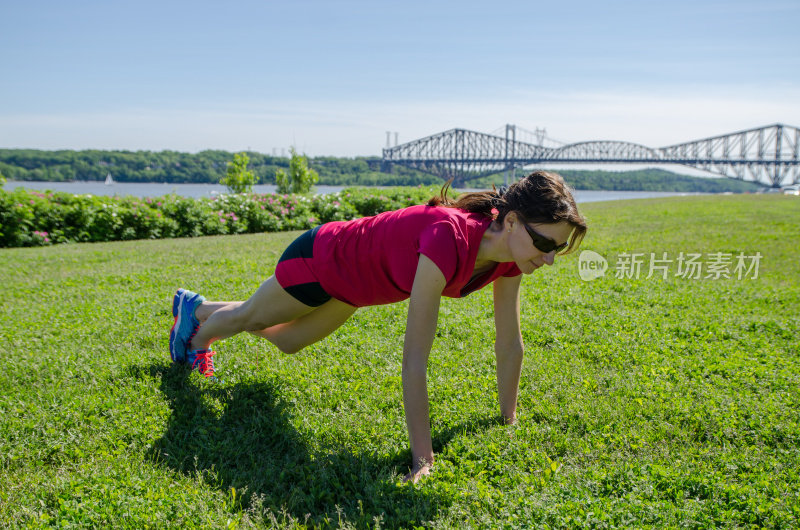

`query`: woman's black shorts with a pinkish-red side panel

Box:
[275,227,331,307]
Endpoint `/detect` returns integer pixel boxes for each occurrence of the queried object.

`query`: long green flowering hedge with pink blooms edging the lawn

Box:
[0,187,436,247]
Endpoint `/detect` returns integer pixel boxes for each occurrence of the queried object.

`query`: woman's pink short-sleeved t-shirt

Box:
[313,206,520,307]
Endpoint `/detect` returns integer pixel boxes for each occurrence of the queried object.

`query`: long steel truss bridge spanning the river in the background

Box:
[381,124,800,187]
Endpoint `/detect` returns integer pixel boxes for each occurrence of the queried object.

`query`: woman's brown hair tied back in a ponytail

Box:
[427,171,586,254]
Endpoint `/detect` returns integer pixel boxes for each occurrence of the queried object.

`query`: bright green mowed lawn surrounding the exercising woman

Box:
[0,196,800,528]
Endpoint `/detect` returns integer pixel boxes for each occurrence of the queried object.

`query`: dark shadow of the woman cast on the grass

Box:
[134,364,494,527]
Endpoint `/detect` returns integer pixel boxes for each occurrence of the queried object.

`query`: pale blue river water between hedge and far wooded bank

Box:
[5,180,698,202]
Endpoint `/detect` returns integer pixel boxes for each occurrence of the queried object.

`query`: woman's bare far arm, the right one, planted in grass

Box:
[493,275,525,424]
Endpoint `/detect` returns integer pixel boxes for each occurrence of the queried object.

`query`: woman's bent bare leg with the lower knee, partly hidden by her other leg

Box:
[195,298,356,353]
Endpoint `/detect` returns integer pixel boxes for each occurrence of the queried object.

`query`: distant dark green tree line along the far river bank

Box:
[0,149,760,193]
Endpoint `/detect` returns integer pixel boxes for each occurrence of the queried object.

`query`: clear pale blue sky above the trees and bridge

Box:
[0,0,800,156]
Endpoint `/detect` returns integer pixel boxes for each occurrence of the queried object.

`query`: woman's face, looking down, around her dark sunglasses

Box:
[503,215,572,274]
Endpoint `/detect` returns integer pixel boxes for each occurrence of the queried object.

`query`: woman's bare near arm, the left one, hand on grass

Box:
[403,254,446,482]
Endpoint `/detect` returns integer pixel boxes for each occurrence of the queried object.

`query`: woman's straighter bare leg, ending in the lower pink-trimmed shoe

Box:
[189,276,315,350]
